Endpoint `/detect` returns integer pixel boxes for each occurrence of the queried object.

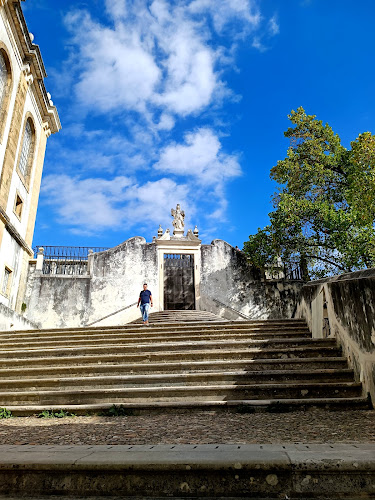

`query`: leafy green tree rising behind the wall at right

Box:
[244,107,375,279]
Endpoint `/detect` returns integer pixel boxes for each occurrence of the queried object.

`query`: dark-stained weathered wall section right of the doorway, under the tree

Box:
[201,240,302,320]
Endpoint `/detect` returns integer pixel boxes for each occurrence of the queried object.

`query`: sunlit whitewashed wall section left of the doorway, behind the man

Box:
[25,237,158,328]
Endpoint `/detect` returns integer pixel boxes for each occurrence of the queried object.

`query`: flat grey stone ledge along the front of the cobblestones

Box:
[0,443,375,470]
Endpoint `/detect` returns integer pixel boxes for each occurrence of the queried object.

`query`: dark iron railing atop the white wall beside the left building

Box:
[33,245,108,275]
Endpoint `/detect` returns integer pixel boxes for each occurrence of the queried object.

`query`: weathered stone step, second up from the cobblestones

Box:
[0,382,362,407]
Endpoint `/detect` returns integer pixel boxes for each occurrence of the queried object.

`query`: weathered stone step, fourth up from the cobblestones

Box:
[0,357,347,380]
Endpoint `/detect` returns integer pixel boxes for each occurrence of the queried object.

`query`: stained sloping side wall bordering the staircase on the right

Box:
[296,269,375,402]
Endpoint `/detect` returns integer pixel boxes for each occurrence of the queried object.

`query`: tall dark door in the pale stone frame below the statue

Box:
[164,254,195,310]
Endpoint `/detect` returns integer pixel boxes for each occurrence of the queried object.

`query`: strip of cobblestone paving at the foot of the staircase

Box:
[0,409,375,445]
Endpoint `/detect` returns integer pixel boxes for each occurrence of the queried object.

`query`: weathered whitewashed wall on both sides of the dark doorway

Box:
[25,237,302,328]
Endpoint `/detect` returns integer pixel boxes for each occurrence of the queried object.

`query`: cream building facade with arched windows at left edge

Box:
[0,0,61,320]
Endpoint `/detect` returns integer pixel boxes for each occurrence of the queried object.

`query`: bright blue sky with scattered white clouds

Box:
[23,0,375,247]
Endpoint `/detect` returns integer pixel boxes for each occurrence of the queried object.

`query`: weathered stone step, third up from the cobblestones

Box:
[0,368,354,391]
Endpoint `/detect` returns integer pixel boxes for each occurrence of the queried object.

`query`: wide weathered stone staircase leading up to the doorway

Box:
[0,311,369,415]
